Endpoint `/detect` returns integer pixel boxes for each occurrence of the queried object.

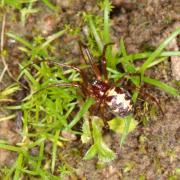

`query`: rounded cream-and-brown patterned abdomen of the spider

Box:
[106,87,133,117]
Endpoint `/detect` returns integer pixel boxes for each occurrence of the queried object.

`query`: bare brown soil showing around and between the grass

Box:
[0,0,180,180]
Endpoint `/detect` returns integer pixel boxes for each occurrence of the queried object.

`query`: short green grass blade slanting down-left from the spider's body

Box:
[66,98,94,130]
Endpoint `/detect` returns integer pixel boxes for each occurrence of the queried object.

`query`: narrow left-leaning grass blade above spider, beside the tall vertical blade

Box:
[88,16,103,53]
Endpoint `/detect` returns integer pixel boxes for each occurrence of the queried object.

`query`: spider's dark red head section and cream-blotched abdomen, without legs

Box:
[89,80,133,117]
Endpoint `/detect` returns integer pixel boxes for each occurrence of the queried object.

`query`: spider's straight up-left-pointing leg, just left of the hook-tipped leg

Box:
[79,41,101,80]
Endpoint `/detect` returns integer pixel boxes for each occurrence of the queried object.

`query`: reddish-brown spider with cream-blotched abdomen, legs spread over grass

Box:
[29,42,162,127]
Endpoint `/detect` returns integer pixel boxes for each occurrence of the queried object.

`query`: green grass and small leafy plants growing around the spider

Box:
[0,0,180,179]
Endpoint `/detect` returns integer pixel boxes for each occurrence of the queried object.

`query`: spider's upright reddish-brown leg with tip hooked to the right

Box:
[101,43,114,83]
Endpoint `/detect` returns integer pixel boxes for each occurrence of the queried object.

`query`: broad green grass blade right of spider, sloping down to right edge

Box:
[143,76,180,96]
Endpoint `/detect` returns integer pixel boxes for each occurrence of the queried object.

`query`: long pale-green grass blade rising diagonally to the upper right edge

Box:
[140,28,180,76]
